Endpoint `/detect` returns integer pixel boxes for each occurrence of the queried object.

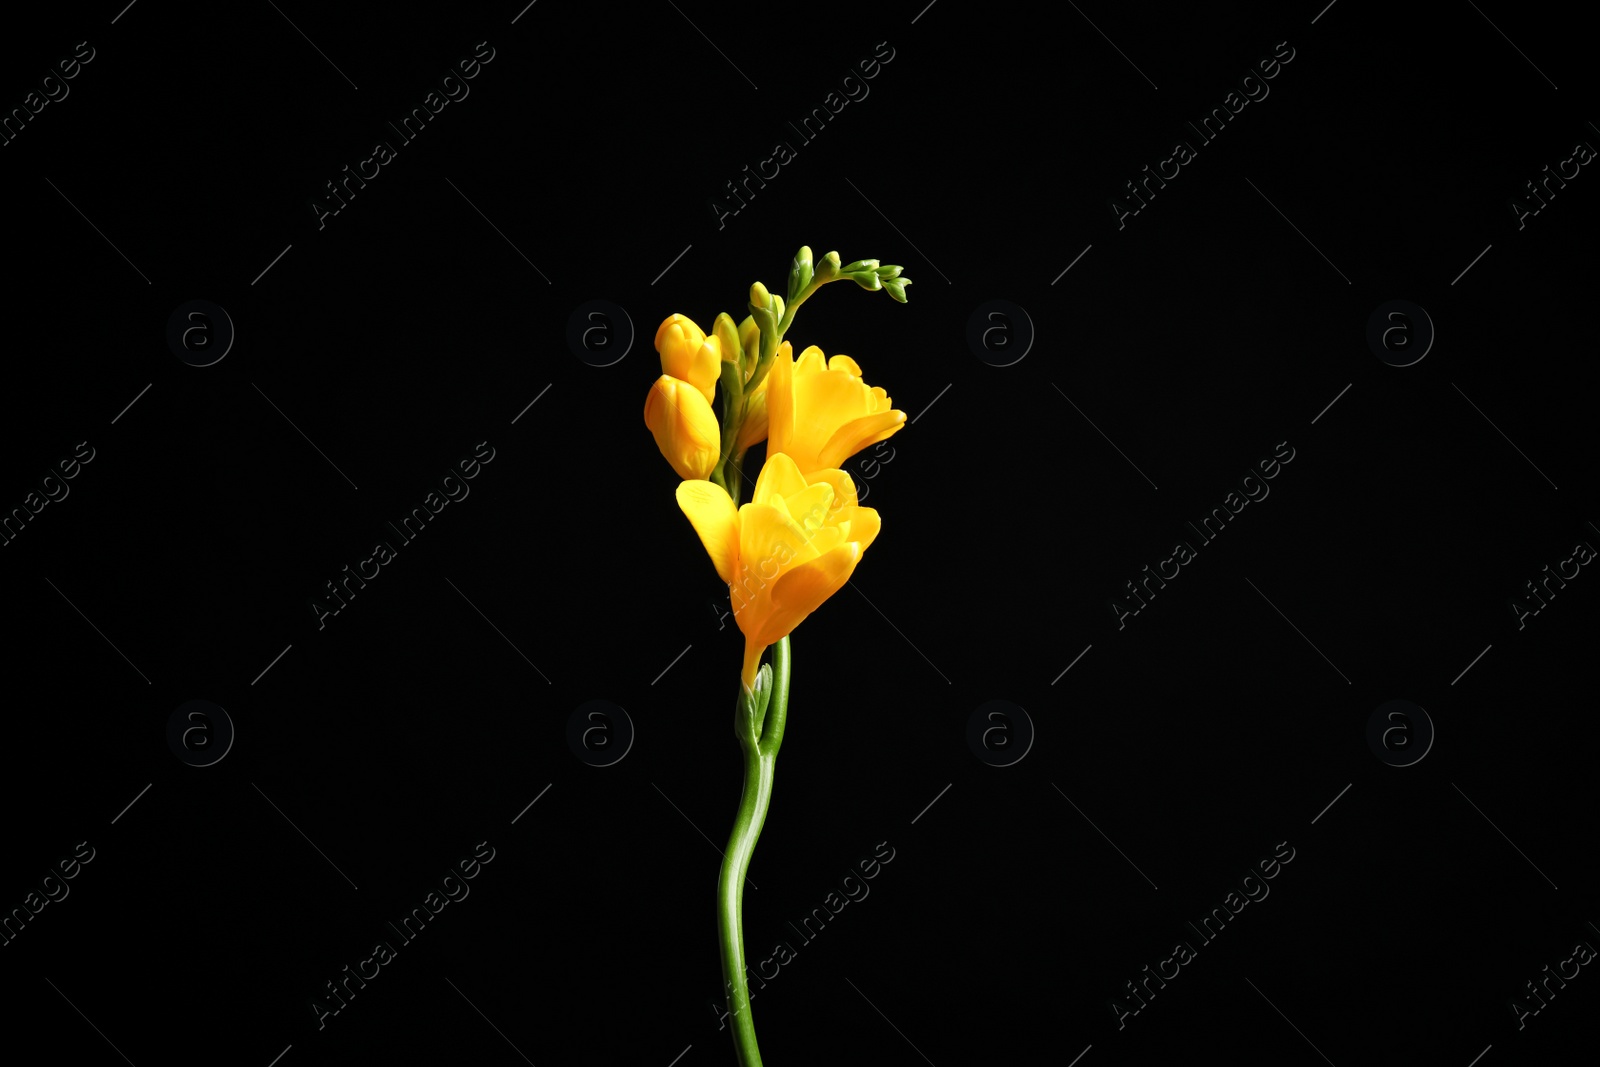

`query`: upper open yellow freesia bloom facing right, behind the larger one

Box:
[766,344,906,470]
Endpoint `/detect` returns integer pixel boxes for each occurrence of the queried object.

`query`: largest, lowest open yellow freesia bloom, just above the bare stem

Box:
[678,453,880,688]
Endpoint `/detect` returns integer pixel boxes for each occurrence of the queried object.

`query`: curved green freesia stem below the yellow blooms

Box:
[717,637,789,1067]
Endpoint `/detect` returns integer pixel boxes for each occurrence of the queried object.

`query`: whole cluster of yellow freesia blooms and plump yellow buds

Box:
[645,315,906,688]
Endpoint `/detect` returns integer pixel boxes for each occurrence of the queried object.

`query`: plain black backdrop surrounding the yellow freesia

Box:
[0,0,1600,1067]
